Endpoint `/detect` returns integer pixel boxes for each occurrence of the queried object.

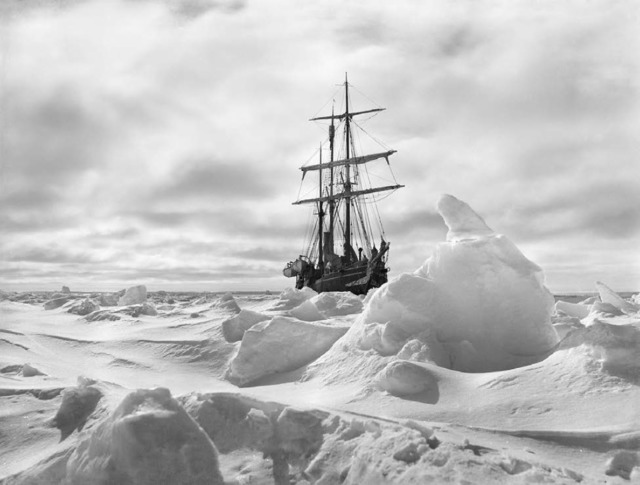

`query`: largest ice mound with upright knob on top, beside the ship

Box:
[338,195,559,372]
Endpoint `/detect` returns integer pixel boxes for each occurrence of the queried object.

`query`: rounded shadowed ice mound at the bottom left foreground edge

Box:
[64,388,224,485]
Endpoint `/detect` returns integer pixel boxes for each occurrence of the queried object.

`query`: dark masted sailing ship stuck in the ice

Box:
[283,75,404,294]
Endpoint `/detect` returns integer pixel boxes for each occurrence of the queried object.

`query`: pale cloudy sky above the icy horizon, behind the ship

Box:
[0,0,640,292]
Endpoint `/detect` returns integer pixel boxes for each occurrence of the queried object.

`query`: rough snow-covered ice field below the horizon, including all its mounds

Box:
[0,197,640,484]
